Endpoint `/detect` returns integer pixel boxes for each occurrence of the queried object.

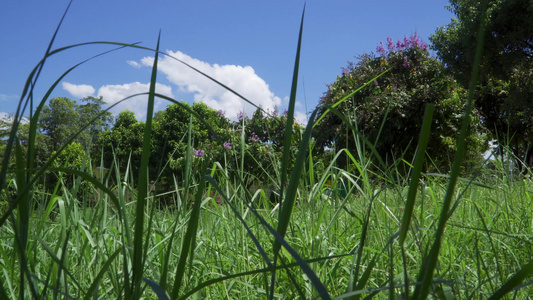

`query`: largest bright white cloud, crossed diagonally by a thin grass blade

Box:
[141,51,282,120]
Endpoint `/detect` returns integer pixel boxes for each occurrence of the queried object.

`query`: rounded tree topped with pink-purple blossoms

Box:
[314,34,487,176]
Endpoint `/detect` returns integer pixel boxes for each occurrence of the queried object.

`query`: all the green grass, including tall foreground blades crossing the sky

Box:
[0,1,533,299]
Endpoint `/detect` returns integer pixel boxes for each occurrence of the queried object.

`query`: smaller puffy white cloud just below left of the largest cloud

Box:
[98,82,172,119]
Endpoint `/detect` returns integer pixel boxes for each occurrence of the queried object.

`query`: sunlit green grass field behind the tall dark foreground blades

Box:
[0,162,533,299]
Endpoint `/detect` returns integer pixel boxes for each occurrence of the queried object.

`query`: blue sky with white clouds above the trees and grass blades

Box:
[0,0,453,123]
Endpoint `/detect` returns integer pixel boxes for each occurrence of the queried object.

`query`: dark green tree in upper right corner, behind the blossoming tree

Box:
[430,0,533,167]
